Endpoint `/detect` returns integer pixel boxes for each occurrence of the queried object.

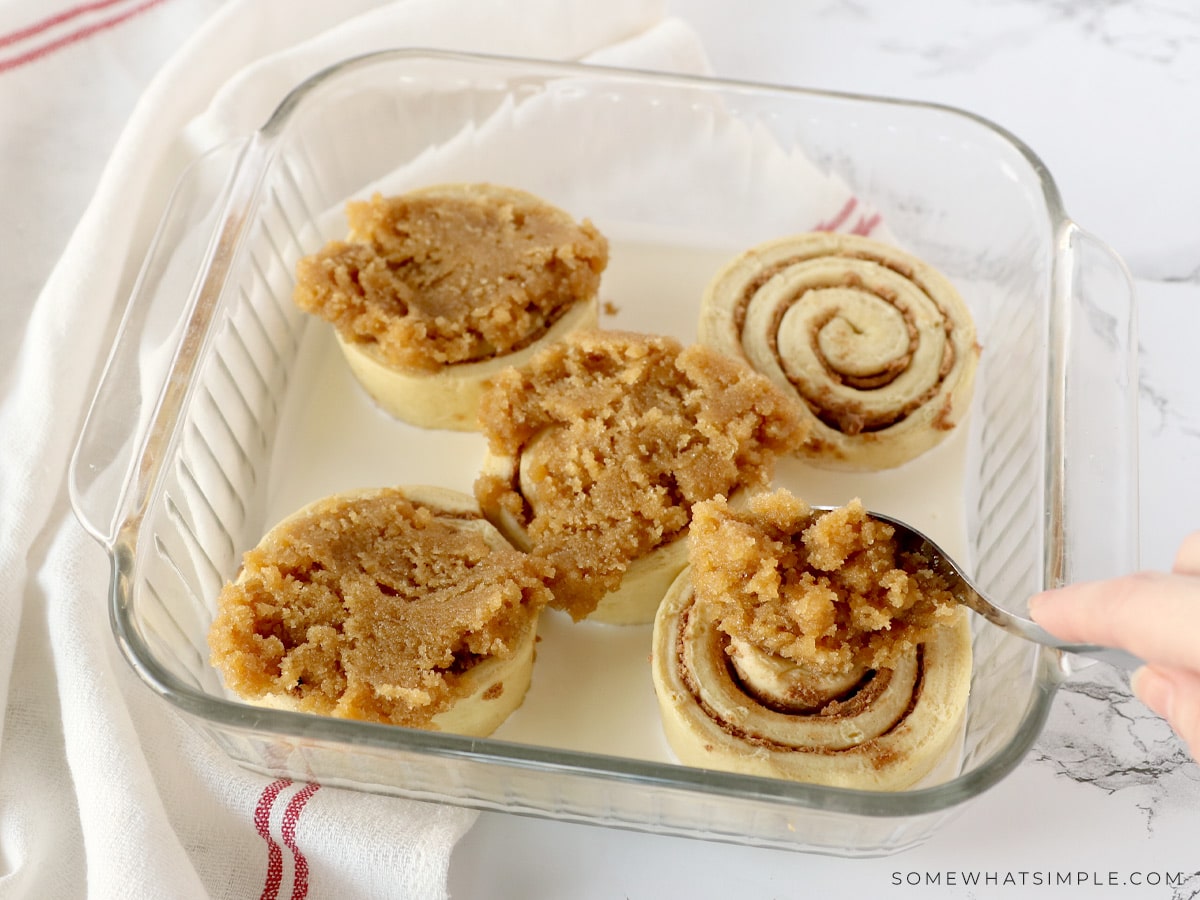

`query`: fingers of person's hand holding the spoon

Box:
[1030,532,1200,760]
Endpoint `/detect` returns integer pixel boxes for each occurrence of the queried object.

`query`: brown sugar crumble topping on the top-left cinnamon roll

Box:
[294,185,608,370]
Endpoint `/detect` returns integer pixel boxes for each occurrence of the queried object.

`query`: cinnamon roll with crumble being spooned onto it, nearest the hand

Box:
[652,491,971,791]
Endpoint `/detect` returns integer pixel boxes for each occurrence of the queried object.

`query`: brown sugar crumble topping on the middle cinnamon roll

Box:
[475,331,805,619]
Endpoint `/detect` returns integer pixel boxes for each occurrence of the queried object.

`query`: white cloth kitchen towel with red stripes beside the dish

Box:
[0,0,704,900]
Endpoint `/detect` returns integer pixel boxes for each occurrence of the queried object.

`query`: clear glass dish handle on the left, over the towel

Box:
[68,139,250,547]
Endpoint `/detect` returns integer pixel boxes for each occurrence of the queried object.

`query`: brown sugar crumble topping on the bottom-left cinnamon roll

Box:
[209,491,550,727]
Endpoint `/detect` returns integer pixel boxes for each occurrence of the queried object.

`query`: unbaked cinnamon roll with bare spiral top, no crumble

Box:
[700,232,979,470]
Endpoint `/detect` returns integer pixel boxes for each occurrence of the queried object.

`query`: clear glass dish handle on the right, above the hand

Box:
[1050,224,1139,587]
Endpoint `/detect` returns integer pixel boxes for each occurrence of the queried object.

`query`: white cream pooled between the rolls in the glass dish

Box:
[265,236,967,779]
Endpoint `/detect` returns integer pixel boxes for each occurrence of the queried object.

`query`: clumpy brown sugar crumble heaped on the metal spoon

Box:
[689,490,956,674]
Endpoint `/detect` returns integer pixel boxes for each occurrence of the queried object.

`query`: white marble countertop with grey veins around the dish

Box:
[450,0,1200,900]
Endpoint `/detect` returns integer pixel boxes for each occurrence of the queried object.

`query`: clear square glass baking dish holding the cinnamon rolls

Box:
[71,50,1138,856]
